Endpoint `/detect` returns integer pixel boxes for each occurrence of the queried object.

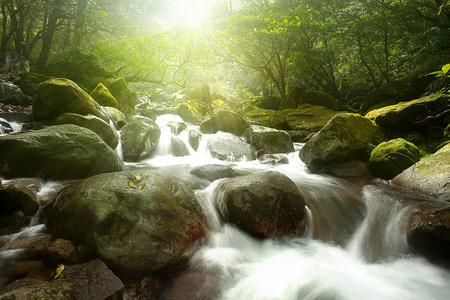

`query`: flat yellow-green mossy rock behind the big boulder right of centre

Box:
[286,104,339,133]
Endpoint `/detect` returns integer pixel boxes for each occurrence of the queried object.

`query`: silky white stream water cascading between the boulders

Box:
[0,116,450,300]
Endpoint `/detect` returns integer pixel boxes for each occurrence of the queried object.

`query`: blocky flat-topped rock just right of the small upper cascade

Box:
[244,125,294,154]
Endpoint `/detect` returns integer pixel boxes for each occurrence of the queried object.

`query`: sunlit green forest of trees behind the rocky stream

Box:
[0,0,450,104]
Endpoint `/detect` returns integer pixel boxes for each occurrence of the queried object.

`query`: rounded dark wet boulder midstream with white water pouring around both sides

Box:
[216,171,305,237]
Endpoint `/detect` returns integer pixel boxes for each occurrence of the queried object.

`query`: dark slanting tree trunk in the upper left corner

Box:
[36,0,63,72]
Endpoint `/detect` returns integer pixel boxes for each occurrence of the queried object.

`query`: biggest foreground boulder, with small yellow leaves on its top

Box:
[46,170,206,276]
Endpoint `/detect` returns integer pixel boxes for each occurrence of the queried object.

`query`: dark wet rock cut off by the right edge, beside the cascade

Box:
[407,206,450,261]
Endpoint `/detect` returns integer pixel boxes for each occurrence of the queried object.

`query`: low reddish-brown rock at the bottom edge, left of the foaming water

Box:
[161,272,220,300]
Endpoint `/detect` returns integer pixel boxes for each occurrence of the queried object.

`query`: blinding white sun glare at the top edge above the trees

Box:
[171,0,211,27]
